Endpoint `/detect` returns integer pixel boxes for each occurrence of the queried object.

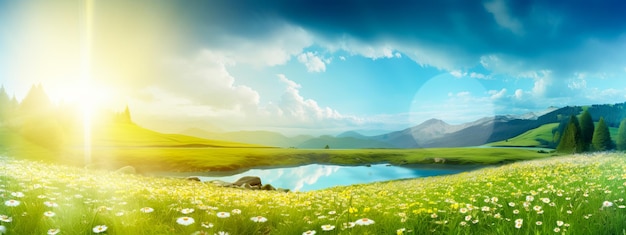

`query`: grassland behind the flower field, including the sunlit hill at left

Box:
[0,124,550,172]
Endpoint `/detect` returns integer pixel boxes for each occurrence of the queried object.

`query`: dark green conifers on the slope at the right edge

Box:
[554,109,626,153]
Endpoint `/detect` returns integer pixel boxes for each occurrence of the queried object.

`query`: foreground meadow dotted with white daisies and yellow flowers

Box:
[0,153,626,235]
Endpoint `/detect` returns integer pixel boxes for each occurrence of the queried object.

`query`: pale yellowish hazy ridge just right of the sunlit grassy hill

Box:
[181,128,314,148]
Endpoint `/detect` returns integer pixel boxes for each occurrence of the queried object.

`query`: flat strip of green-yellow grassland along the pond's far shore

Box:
[64,148,550,172]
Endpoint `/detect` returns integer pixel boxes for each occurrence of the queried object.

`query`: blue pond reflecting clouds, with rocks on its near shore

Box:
[190,164,482,192]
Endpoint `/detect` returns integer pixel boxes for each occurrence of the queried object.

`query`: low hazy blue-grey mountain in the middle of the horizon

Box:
[297,135,396,149]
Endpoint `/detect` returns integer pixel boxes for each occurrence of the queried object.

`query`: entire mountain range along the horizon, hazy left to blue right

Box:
[181,103,626,149]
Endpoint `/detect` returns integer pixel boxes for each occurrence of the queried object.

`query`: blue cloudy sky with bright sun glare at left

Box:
[0,0,626,135]
